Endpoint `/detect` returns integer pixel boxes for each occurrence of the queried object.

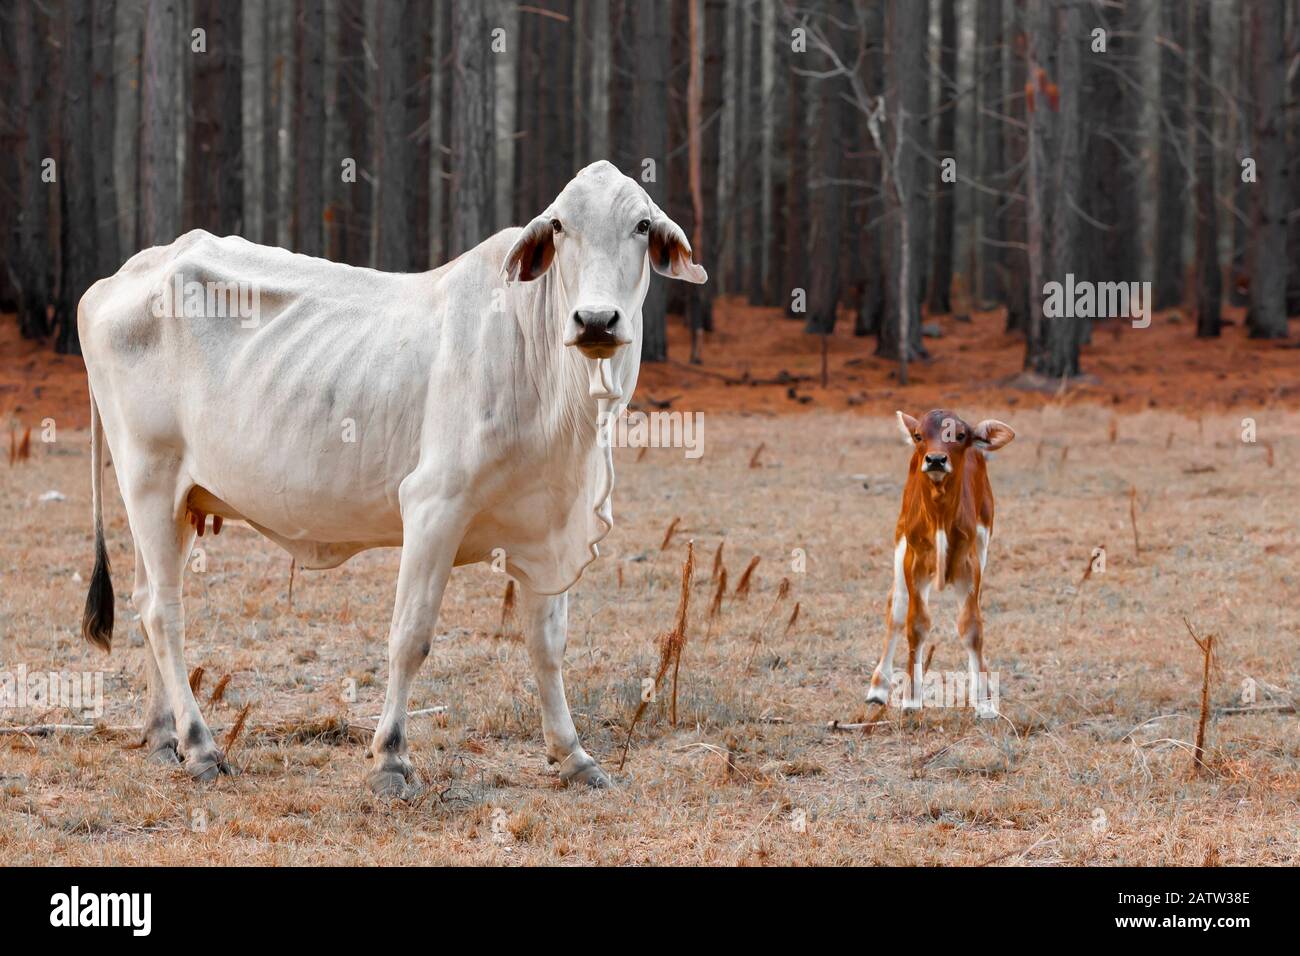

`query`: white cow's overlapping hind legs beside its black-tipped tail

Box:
[118,468,231,782]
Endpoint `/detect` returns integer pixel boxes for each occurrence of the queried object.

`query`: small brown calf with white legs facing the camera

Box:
[867,408,1015,717]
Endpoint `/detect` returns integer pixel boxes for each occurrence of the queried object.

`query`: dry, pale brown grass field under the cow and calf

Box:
[0,403,1300,865]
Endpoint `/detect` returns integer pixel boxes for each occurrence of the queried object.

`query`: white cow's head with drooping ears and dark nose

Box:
[502,160,709,359]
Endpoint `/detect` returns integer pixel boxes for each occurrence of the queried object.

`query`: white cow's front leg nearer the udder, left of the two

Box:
[367,502,460,797]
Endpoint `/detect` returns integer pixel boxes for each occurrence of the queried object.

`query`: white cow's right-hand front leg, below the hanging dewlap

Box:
[520,587,611,787]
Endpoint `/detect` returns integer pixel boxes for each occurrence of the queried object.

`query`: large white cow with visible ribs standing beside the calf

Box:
[78,161,707,795]
